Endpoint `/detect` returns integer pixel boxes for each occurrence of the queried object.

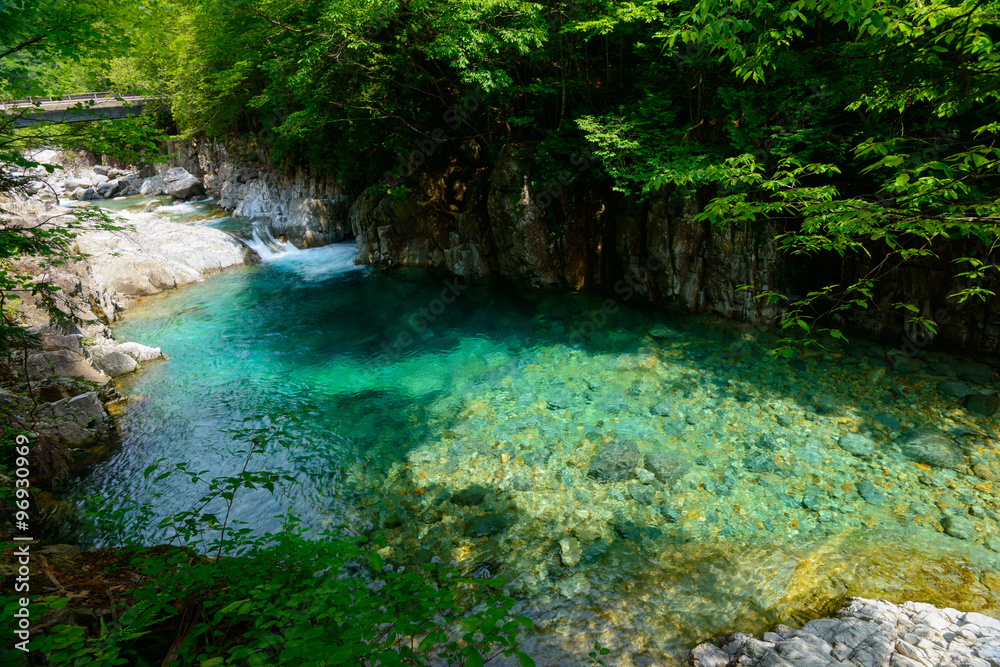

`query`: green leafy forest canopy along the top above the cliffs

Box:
[0,0,1000,340]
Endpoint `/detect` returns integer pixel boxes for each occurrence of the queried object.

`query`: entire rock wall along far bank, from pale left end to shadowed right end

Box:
[164,136,1000,351]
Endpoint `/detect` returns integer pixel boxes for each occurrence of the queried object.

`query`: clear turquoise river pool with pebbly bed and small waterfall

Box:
[58,198,1000,664]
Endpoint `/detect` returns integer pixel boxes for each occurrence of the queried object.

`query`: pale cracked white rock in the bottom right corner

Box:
[691,598,1000,667]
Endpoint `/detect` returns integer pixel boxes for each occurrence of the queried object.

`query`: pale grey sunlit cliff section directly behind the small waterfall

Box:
[157,140,351,248]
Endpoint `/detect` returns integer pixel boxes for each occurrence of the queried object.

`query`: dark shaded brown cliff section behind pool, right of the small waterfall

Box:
[350,145,777,321]
